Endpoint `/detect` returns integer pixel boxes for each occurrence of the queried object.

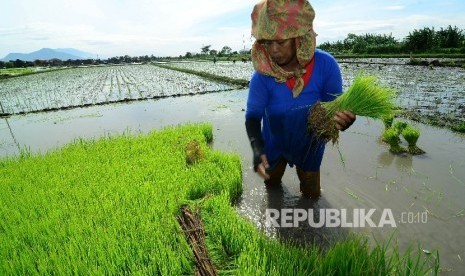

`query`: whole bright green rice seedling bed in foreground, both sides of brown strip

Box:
[0,123,438,275]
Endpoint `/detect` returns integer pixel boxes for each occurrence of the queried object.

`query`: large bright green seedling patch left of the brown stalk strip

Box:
[0,124,242,275]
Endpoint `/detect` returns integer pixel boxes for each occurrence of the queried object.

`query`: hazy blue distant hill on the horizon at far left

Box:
[1,48,95,61]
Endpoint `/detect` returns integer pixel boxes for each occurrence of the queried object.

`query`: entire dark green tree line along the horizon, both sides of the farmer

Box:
[0,25,465,69]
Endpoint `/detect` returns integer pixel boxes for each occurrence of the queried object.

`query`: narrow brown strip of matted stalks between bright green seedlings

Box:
[178,206,218,276]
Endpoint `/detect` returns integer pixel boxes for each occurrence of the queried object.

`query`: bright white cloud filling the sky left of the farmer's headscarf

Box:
[0,0,253,56]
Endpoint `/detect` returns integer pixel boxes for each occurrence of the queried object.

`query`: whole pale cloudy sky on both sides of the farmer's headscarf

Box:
[0,0,465,58]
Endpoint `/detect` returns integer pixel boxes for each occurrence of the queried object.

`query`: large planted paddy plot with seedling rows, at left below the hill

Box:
[0,65,231,115]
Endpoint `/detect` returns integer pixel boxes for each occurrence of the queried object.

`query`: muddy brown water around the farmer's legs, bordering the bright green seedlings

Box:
[0,90,465,275]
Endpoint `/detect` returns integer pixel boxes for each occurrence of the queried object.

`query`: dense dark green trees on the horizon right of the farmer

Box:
[318,25,465,54]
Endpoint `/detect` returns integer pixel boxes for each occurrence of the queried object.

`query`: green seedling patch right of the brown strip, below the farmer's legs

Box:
[201,194,439,275]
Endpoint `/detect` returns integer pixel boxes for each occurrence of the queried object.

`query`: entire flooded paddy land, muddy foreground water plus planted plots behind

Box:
[0,59,465,275]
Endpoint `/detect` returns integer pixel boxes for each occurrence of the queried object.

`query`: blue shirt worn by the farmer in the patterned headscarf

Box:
[245,49,342,171]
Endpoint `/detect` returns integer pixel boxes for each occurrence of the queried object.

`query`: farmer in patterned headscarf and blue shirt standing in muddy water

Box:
[245,0,355,198]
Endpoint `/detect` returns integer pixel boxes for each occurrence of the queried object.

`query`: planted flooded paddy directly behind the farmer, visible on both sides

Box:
[164,58,465,128]
